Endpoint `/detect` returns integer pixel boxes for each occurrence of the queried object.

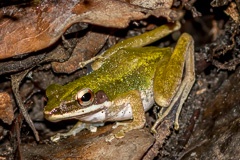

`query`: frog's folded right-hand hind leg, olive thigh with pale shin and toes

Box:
[152,33,195,132]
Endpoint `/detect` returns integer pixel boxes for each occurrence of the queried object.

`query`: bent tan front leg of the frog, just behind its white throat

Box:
[111,90,146,138]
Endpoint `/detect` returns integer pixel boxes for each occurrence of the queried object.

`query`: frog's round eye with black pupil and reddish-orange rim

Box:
[76,88,94,107]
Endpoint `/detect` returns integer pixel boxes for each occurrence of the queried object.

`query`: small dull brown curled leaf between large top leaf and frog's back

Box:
[52,31,108,74]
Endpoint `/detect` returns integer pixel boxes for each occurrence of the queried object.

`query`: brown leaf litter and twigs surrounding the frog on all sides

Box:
[0,0,240,159]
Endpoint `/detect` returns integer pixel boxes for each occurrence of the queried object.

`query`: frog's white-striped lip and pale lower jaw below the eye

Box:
[44,101,112,122]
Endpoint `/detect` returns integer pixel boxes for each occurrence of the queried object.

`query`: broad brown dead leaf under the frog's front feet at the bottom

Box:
[22,125,154,160]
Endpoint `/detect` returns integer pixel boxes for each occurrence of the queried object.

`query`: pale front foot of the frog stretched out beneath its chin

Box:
[50,121,103,142]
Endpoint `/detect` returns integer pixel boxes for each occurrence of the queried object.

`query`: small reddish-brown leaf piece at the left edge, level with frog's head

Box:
[0,92,14,125]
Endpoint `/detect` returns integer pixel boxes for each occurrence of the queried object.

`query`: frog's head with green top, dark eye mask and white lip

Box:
[44,84,111,122]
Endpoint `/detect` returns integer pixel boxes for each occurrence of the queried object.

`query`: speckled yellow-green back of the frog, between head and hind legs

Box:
[92,47,171,99]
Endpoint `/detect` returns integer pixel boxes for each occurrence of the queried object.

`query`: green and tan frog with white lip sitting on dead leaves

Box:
[44,22,195,141]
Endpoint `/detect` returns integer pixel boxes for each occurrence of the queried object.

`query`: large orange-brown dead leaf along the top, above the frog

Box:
[0,0,177,59]
